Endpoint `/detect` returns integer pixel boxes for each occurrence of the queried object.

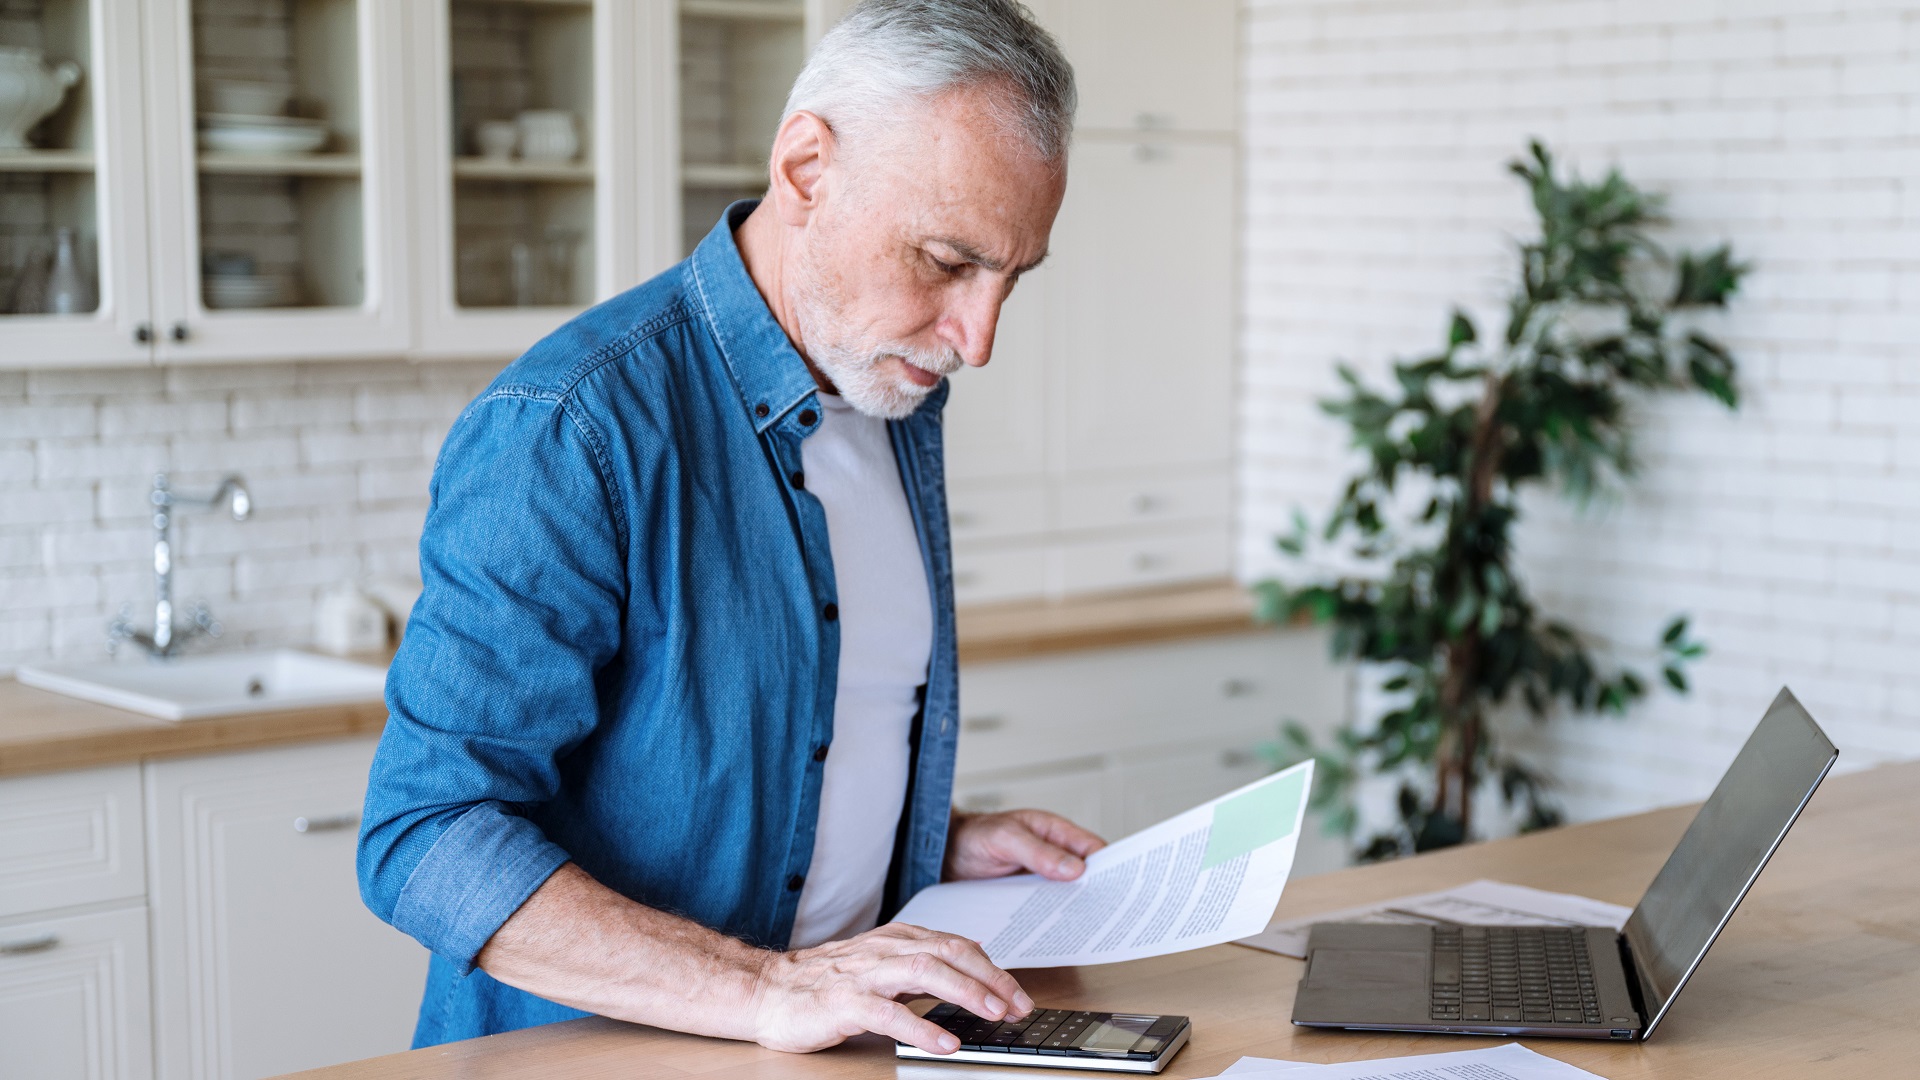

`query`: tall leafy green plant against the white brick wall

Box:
[1256,142,1745,859]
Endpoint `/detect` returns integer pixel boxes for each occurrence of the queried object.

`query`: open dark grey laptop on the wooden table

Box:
[1294,690,1839,1040]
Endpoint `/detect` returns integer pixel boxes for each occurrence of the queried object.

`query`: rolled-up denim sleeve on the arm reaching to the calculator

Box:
[359,388,626,972]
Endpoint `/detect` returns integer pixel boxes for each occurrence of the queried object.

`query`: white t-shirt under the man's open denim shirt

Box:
[789,394,933,949]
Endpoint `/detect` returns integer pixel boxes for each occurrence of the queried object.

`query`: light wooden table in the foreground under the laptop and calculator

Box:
[280,763,1920,1080]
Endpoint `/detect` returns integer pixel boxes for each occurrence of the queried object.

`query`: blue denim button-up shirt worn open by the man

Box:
[359,202,956,1045]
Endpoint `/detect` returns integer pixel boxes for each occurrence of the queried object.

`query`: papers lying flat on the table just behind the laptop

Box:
[1235,880,1632,959]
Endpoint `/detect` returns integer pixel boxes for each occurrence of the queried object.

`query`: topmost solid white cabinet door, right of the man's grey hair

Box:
[1043,0,1238,131]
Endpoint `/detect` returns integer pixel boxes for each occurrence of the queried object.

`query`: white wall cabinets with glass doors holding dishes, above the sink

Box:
[0,0,845,367]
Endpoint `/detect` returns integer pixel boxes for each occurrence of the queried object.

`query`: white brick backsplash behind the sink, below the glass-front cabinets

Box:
[0,361,497,673]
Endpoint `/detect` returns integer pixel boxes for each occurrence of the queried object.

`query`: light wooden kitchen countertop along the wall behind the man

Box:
[0,582,1254,776]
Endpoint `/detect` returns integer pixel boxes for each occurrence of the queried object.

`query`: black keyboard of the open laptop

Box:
[1432,926,1599,1024]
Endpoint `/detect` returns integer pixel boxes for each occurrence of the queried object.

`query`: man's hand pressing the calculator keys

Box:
[753,922,1033,1053]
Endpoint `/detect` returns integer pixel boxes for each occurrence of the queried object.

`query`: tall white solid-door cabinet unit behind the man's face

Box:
[947,0,1238,603]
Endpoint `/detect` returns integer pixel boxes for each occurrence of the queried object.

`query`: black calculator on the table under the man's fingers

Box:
[893,1001,1190,1072]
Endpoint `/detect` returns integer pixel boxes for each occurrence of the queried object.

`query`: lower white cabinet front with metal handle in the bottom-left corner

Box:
[0,907,154,1080]
